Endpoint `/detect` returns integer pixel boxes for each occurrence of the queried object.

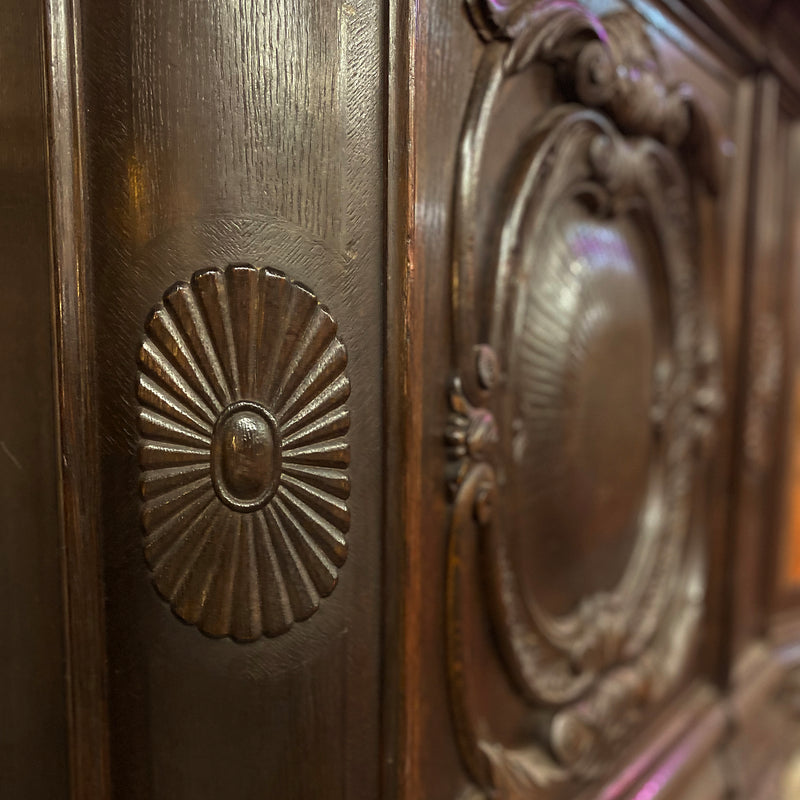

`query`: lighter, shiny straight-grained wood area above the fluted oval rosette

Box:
[130,0,346,249]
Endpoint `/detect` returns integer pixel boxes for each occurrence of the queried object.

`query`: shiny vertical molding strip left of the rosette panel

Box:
[44,0,110,800]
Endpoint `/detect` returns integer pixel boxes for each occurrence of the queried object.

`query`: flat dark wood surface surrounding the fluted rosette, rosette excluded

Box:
[77,0,385,800]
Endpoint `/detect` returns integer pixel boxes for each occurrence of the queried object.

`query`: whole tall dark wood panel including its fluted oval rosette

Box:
[77,0,388,800]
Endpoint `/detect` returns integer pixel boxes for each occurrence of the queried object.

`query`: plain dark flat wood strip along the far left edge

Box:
[0,2,71,800]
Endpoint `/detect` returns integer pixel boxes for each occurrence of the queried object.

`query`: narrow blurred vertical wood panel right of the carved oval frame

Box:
[719,73,786,677]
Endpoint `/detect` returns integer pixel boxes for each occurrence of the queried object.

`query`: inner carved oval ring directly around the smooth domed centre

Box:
[486,106,697,704]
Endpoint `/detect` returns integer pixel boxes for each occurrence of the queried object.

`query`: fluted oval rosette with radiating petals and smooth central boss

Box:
[138,265,350,641]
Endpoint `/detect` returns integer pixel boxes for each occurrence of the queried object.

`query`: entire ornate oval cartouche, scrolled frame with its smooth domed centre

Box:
[446,0,723,798]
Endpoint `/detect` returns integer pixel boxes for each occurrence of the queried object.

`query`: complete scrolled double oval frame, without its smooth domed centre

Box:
[446,0,723,797]
